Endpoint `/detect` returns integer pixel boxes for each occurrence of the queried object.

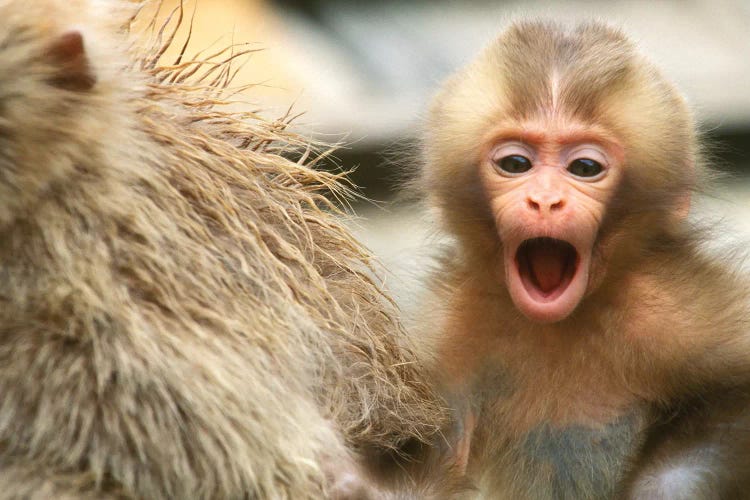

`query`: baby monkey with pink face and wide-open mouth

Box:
[413,21,750,499]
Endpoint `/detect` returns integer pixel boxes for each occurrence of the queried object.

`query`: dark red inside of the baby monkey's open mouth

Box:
[516,238,580,302]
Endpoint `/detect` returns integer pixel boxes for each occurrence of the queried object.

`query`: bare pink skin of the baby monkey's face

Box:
[481,120,622,323]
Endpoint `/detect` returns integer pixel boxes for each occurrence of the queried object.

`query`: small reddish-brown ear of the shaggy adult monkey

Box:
[46,30,96,92]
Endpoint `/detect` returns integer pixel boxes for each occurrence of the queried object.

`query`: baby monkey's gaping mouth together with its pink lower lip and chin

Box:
[505,237,591,323]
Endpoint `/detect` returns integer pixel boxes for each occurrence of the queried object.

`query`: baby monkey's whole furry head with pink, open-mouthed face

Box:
[421,22,695,323]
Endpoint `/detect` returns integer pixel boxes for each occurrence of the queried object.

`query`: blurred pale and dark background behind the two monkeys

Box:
[156,0,750,300]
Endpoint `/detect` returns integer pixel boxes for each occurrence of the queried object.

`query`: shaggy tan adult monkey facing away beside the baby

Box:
[0,0,450,499]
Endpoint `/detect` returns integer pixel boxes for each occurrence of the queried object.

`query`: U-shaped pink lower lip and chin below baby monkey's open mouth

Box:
[505,255,590,324]
